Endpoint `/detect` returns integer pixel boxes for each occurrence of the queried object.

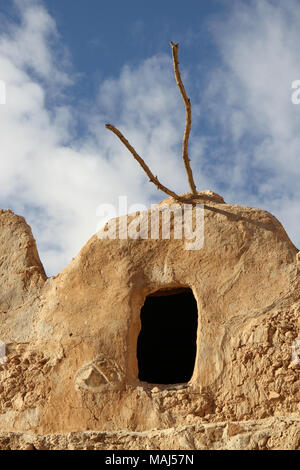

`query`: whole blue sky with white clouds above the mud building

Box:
[0,0,300,276]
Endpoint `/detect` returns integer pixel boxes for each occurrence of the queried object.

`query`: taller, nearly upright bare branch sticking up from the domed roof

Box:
[170,41,197,194]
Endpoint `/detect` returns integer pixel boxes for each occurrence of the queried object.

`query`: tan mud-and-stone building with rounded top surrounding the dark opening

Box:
[0,192,300,449]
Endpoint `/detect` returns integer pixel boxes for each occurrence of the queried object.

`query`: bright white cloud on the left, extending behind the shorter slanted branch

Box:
[0,1,202,275]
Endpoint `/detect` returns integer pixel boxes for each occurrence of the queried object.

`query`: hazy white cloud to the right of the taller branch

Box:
[206,0,300,250]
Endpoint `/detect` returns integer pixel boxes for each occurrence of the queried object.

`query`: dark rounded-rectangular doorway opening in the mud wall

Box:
[137,288,198,384]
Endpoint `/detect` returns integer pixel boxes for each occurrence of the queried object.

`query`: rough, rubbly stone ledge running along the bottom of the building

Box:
[0,416,300,450]
